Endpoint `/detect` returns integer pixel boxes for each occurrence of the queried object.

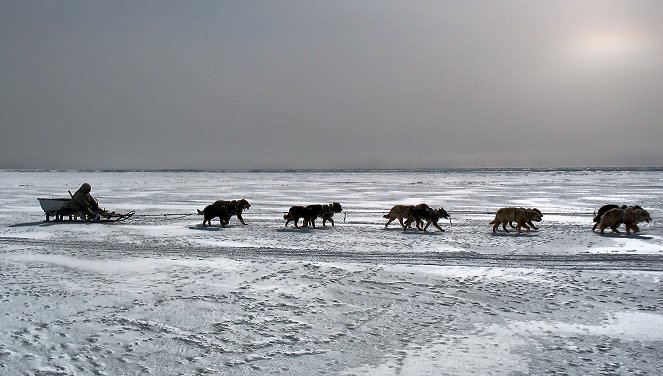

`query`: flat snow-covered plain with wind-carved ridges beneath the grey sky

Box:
[0,170,663,375]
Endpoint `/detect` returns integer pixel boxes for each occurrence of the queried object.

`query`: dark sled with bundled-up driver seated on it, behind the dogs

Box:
[37,183,135,222]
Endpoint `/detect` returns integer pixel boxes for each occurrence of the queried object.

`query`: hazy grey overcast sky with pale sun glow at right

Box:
[0,0,663,169]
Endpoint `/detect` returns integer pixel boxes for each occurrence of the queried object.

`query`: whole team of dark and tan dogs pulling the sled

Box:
[198,199,652,235]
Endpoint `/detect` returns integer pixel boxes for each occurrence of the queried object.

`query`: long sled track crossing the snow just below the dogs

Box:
[0,237,663,271]
